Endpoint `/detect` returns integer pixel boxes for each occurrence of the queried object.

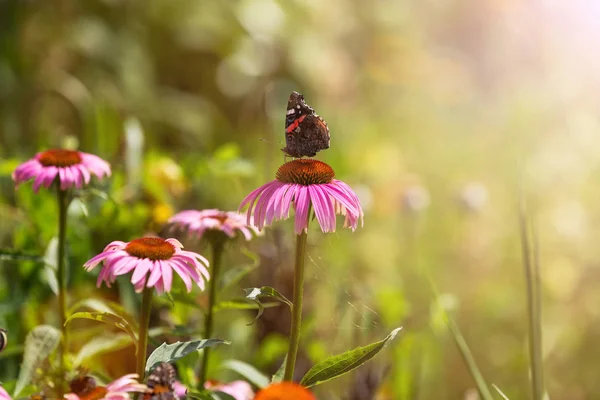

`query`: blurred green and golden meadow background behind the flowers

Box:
[0,0,600,400]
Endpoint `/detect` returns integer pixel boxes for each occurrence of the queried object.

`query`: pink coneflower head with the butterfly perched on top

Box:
[240,158,363,235]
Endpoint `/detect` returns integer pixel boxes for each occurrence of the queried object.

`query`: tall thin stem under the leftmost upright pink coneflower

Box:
[56,188,69,398]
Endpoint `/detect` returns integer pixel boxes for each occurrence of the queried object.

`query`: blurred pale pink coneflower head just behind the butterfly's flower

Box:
[167,209,258,240]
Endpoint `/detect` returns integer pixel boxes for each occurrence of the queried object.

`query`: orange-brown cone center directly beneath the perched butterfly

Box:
[276,158,335,186]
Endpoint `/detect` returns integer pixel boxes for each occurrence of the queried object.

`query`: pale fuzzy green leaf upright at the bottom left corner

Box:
[13,325,61,398]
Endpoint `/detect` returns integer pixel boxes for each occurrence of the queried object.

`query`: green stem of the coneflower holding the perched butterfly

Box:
[283,228,310,381]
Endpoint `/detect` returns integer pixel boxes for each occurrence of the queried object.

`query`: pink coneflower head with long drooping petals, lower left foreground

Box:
[84,237,210,294]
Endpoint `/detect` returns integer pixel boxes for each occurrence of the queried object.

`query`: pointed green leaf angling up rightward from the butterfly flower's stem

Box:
[300,328,402,387]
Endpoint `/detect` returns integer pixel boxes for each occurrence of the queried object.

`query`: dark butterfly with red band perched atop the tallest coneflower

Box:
[281,92,331,158]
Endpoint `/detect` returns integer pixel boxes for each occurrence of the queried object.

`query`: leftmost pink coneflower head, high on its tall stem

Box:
[12,149,110,193]
